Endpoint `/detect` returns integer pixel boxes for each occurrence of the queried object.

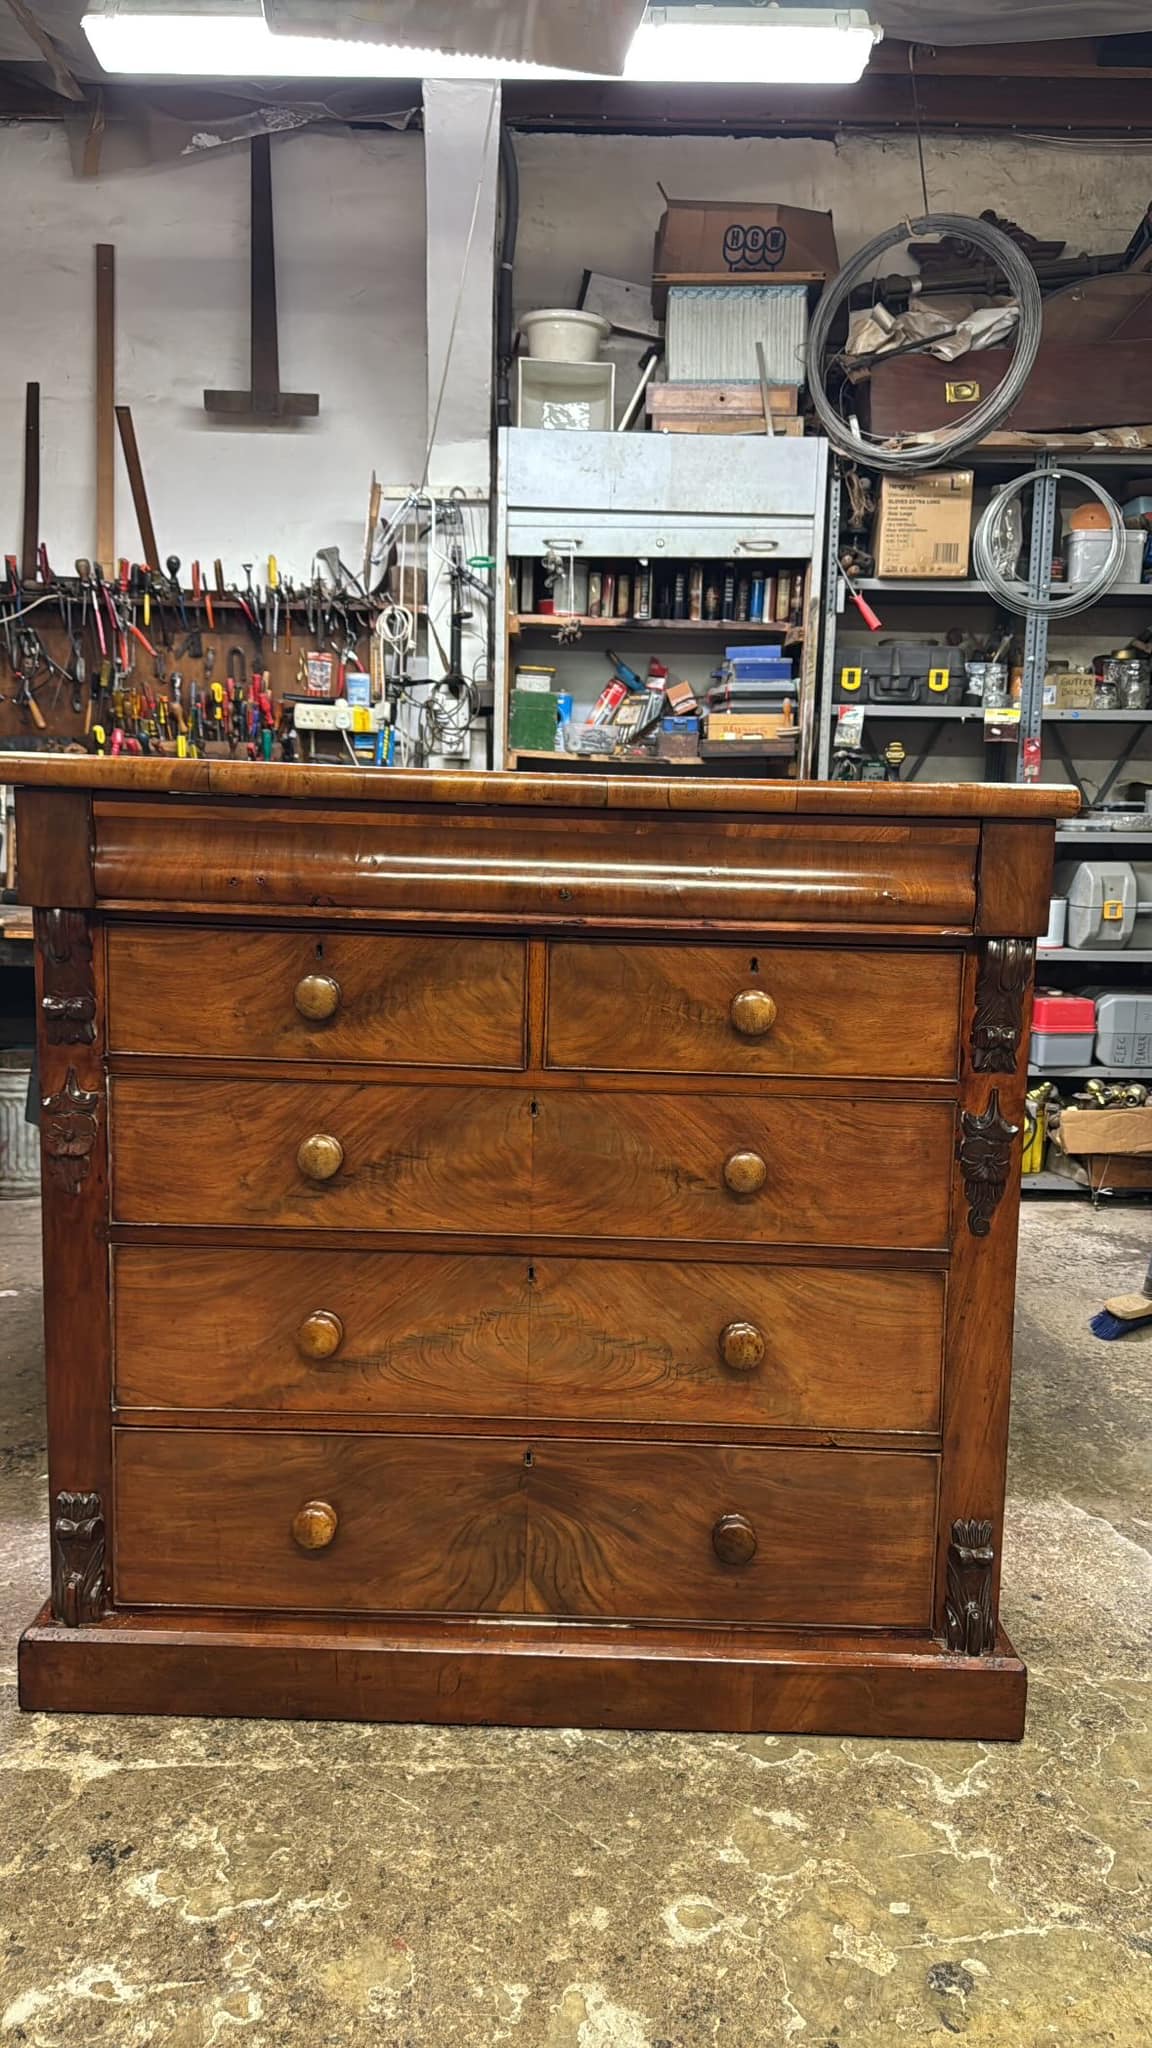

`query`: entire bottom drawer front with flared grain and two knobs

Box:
[115,1430,937,1628]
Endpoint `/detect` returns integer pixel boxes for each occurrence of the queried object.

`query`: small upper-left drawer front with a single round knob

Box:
[109,926,525,1067]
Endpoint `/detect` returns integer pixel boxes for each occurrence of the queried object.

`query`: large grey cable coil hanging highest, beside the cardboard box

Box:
[808,213,1043,475]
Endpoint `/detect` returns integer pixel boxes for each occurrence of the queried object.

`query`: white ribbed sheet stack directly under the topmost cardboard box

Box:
[666,285,808,385]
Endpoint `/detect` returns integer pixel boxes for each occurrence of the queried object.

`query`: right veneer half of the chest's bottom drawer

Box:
[527,1442,937,1628]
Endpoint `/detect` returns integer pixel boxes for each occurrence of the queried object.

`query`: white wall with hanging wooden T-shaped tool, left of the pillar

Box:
[0,123,426,580]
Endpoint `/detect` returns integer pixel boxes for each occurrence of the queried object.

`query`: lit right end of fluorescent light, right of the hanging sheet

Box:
[623,6,883,86]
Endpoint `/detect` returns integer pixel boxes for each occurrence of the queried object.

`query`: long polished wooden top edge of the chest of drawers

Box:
[4,754,1080,819]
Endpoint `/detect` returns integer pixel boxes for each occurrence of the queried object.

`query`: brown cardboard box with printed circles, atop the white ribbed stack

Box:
[652,199,840,313]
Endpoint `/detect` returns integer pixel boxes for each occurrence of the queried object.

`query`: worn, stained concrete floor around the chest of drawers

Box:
[0,1198,1152,2048]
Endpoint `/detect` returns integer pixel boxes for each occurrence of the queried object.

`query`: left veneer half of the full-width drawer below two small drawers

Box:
[113,1077,533,1233]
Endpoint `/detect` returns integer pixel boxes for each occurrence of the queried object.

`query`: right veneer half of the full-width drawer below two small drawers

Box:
[533,1090,955,1249]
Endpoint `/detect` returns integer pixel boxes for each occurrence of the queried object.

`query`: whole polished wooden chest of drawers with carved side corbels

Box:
[6,760,1076,1737]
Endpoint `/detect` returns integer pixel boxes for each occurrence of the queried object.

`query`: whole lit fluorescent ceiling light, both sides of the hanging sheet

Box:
[84,0,883,86]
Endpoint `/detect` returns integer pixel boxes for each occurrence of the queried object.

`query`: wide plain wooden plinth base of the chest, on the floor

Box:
[18,1612,1027,1741]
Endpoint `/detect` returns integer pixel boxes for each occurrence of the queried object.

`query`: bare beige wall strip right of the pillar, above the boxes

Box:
[517,135,1152,311]
